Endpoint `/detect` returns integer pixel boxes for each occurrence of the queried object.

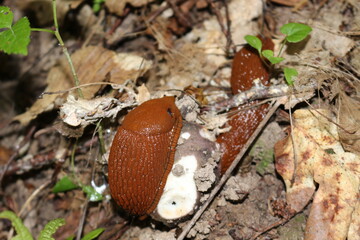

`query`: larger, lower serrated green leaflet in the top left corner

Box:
[0,17,31,55]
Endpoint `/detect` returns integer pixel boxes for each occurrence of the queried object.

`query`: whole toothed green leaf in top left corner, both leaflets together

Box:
[0,7,31,55]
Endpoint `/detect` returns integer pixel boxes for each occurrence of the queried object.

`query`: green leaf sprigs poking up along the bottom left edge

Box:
[0,211,105,240]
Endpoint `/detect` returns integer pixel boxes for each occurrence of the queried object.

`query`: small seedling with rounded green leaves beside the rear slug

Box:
[245,23,312,85]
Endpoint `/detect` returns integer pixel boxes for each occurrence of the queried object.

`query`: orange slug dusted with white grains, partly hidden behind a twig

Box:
[217,38,274,174]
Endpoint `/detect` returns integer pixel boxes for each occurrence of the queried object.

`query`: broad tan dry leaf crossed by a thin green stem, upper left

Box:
[13,46,152,125]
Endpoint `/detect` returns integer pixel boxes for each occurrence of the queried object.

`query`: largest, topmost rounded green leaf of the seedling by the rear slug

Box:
[280,23,312,42]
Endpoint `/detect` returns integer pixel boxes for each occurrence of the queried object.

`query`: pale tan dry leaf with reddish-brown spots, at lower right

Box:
[275,109,360,240]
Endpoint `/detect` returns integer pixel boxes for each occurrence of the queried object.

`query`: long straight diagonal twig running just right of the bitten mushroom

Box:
[177,97,287,240]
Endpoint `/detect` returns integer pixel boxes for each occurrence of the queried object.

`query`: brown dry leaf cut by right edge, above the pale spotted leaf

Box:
[338,93,360,154]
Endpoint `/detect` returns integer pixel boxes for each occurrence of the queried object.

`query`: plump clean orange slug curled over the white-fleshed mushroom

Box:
[108,97,182,216]
